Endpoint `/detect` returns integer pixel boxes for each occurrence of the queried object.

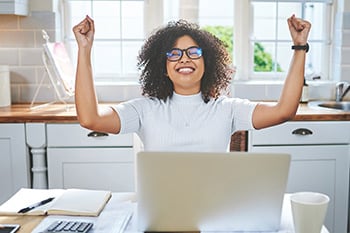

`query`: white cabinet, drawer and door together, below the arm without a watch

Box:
[46,124,137,192]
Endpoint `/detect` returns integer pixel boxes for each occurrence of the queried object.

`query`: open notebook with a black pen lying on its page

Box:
[0,188,112,216]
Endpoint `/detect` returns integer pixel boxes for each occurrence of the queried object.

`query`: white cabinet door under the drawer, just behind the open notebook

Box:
[47,148,135,192]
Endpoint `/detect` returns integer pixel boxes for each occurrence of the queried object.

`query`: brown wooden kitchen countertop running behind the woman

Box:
[0,103,350,123]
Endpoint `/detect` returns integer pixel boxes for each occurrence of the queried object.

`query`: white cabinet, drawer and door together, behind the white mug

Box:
[248,121,350,233]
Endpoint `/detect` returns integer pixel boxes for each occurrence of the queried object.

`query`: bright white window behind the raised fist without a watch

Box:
[64,0,144,82]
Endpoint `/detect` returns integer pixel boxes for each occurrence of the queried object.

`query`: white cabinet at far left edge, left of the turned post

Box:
[0,123,30,204]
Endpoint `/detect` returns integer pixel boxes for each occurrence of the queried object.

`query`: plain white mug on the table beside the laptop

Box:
[290,192,329,233]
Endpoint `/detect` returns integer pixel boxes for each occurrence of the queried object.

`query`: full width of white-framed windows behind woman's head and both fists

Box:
[63,0,333,82]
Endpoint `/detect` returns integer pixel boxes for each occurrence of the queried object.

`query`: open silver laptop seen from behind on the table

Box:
[136,151,290,231]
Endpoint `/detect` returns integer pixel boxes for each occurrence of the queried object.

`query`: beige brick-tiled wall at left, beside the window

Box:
[0,0,59,103]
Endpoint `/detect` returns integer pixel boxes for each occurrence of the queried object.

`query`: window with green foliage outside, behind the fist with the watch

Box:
[235,0,332,80]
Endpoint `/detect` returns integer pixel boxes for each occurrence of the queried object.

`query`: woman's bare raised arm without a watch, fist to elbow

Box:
[73,16,120,133]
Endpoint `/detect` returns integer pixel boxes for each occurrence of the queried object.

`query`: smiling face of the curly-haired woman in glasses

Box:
[166,35,204,95]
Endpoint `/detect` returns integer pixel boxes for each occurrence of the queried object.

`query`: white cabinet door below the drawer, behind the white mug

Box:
[251,145,350,233]
